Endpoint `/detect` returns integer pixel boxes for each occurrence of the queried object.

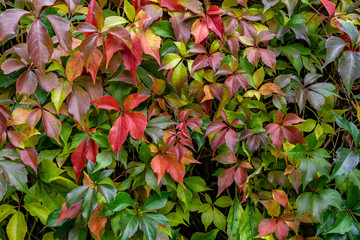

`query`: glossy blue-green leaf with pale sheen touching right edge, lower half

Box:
[332,148,359,178]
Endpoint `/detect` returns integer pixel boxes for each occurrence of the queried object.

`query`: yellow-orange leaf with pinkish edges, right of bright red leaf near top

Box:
[137,28,161,66]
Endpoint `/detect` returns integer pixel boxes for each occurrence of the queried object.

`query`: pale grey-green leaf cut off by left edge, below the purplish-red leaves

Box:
[0,160,28,193]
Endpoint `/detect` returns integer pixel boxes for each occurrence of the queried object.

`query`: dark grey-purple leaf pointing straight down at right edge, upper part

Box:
[338,51,360,96]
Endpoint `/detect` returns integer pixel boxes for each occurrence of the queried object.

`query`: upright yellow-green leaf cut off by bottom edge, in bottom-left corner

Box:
[6,211,27,240]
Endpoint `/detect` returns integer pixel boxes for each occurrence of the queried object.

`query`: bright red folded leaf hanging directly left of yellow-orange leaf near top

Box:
[121,36,142,83]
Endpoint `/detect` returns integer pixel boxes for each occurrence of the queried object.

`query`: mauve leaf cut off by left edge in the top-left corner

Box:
[0,8,30,42]
